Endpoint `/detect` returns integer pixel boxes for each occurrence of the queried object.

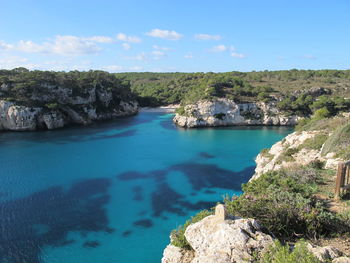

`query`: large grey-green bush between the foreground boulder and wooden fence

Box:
[225,166,349,240]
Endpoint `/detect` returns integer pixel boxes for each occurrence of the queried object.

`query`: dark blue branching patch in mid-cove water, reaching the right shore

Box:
[117,162,255,217]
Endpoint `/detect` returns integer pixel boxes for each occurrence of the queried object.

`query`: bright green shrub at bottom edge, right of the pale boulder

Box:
[261,241,320,263]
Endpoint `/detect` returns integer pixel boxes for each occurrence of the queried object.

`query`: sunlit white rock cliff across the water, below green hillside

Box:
[173,99,300,128]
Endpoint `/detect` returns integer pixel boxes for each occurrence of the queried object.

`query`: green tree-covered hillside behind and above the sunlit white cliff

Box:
[116,69,350,115]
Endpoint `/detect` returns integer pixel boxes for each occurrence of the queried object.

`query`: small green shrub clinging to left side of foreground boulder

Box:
[171,210,213,249]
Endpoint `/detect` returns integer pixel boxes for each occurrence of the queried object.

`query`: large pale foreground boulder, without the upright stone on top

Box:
[162,215,273,263]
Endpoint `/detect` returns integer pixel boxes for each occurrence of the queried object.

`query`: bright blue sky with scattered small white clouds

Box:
[0,0,350,72]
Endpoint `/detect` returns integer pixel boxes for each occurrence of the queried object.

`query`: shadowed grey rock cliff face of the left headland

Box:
[0,84,138,131]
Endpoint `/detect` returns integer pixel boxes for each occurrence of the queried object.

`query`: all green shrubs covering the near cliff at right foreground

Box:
[172,114,350,262]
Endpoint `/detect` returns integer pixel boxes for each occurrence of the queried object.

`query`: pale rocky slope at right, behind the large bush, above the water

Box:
[250,131,343,181]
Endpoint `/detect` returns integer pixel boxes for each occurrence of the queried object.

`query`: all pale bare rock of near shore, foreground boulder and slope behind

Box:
[162,118,350,263]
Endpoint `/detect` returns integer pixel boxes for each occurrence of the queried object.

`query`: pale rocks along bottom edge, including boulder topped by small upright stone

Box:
[162,208,350,263]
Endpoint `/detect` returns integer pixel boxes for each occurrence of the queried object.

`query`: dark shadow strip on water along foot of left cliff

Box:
[0,113,161,145]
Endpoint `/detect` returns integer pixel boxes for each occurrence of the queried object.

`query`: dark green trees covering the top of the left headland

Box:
[0,68,134,109]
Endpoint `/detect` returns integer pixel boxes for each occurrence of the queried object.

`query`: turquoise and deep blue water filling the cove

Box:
[0,113,290,263]
